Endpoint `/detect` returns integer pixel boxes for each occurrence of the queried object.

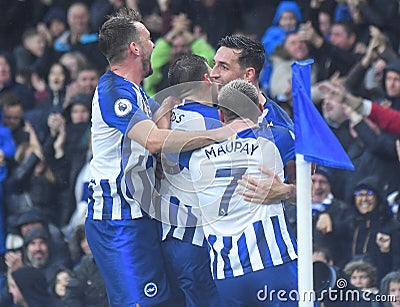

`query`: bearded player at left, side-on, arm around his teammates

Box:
[85,8,250,306]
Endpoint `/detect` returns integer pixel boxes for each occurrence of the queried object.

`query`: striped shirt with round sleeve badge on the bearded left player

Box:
[87,71,158,220]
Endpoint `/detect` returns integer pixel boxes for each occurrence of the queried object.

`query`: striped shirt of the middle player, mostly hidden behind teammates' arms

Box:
[160,100,221,246]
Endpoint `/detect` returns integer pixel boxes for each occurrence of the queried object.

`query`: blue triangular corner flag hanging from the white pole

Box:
[292,60,354,170]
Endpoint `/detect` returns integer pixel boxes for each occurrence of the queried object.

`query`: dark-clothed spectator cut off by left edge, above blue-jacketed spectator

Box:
[0,51,35,111]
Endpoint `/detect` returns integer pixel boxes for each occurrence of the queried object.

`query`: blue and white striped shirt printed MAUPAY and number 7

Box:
[188,125,297,279]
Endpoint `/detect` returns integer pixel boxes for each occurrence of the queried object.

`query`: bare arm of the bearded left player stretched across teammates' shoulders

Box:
[128,119,254,153]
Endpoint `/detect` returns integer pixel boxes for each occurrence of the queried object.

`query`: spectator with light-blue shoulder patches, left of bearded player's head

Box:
[54,2,107,70]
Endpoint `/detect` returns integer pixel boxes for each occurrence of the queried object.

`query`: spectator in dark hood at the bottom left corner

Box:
[8,267,63,307]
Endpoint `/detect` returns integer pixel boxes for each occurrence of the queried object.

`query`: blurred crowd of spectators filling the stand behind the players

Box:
[0,0,400,306]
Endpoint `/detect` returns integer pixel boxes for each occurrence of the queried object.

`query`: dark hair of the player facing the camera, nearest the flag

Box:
[218,35,265,79]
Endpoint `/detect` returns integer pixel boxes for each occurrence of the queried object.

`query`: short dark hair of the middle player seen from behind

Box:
[168,54,208,86]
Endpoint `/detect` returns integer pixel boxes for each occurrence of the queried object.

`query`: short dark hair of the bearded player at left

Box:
[99,8,142,64]
